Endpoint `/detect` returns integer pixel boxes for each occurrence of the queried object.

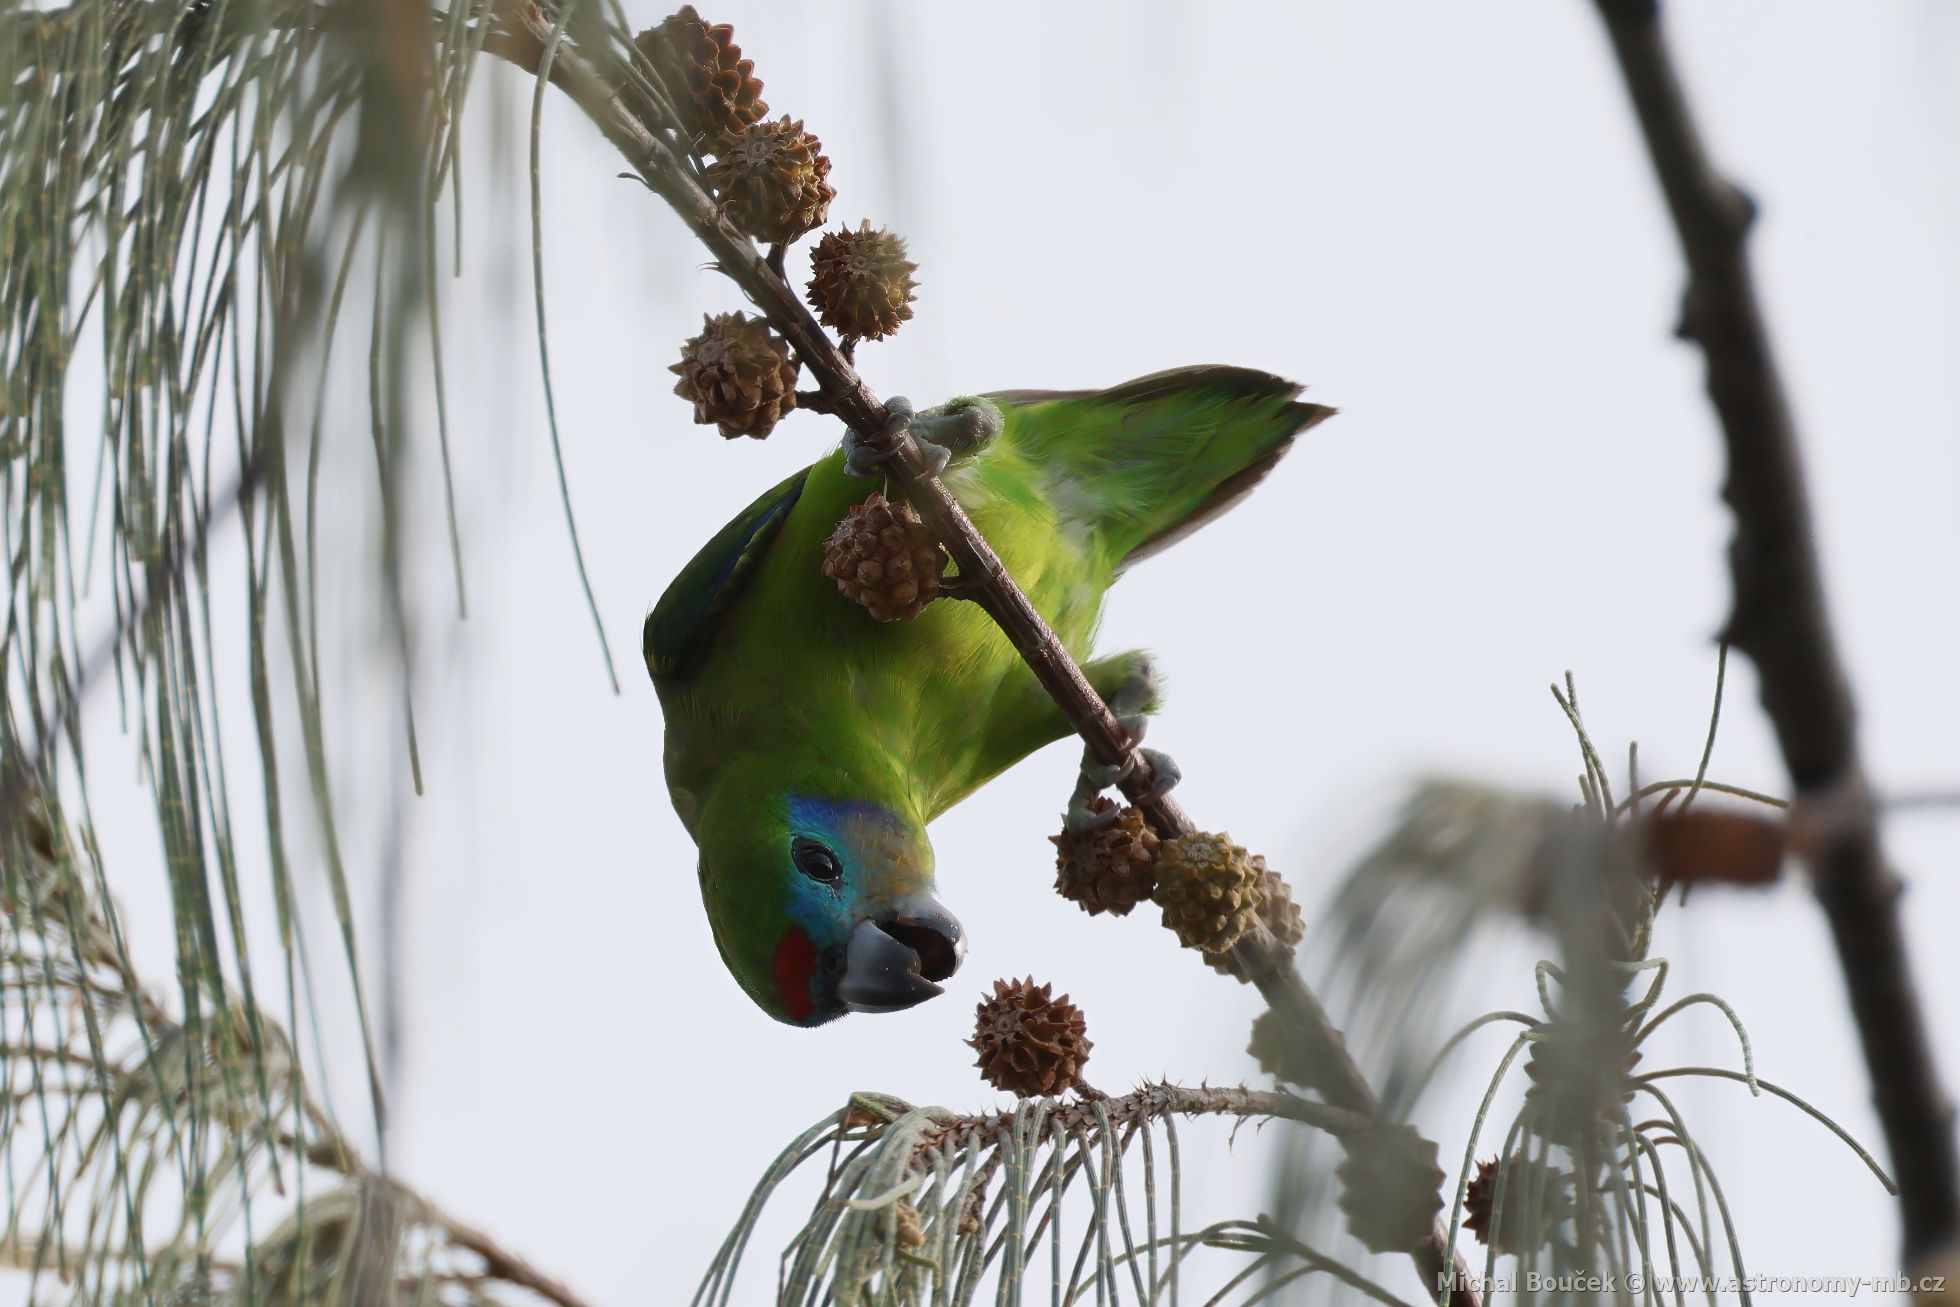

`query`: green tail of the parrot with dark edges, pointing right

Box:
[992,366,1333,572]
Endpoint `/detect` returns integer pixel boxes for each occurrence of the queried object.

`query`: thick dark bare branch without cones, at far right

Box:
[1595,0,1960,1266]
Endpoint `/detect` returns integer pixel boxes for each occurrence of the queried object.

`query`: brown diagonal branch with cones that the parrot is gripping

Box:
[486,15,1478,1307]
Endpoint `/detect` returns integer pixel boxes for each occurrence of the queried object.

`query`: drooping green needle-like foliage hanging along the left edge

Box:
[0,0,623,1301]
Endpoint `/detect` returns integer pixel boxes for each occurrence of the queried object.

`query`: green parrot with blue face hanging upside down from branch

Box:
[643,366,1333,1027]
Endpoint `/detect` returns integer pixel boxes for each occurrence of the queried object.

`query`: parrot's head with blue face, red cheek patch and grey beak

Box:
[696,788,966,1025]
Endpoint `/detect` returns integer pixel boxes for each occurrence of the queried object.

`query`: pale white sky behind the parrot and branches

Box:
[38,0,1960,1303]
